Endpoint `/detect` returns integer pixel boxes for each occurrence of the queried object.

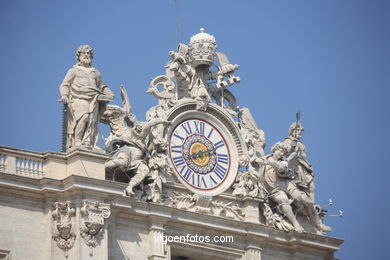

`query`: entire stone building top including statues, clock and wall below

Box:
[0,29,343,260]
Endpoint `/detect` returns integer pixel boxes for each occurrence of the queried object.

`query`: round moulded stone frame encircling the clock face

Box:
[165,99,246,196]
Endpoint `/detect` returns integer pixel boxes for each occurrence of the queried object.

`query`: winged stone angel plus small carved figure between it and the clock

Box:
[101,85,170,201]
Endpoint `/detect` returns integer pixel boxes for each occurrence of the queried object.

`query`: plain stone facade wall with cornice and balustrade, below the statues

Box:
[0,147,343,260]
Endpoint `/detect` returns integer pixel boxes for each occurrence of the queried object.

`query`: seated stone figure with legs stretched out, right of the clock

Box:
[260,136,331,234]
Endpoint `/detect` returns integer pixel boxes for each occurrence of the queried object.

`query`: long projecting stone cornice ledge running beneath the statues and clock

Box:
[0,173,343,251]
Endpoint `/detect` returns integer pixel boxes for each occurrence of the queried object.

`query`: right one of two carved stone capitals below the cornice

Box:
[80,200,111,249]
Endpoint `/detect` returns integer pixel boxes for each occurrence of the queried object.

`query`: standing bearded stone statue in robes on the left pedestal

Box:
[60,45,114,148]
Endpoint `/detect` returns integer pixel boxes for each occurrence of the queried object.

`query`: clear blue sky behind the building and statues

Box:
[0,0,390,260]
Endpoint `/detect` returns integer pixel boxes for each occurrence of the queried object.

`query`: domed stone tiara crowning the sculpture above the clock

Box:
[188,28,217,67]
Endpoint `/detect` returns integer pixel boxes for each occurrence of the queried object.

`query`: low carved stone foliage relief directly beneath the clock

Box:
[168,192,245,221]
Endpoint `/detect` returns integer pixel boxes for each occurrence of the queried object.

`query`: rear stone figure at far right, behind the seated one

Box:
[283,122,314,202]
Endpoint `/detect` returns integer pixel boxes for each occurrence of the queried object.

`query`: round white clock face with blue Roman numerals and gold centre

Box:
[169,118,232,195]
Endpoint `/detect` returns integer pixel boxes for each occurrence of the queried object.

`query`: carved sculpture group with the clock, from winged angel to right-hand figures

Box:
[95,29,331,236]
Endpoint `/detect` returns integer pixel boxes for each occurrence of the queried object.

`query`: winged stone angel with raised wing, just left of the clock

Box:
[102,86,169,197]
